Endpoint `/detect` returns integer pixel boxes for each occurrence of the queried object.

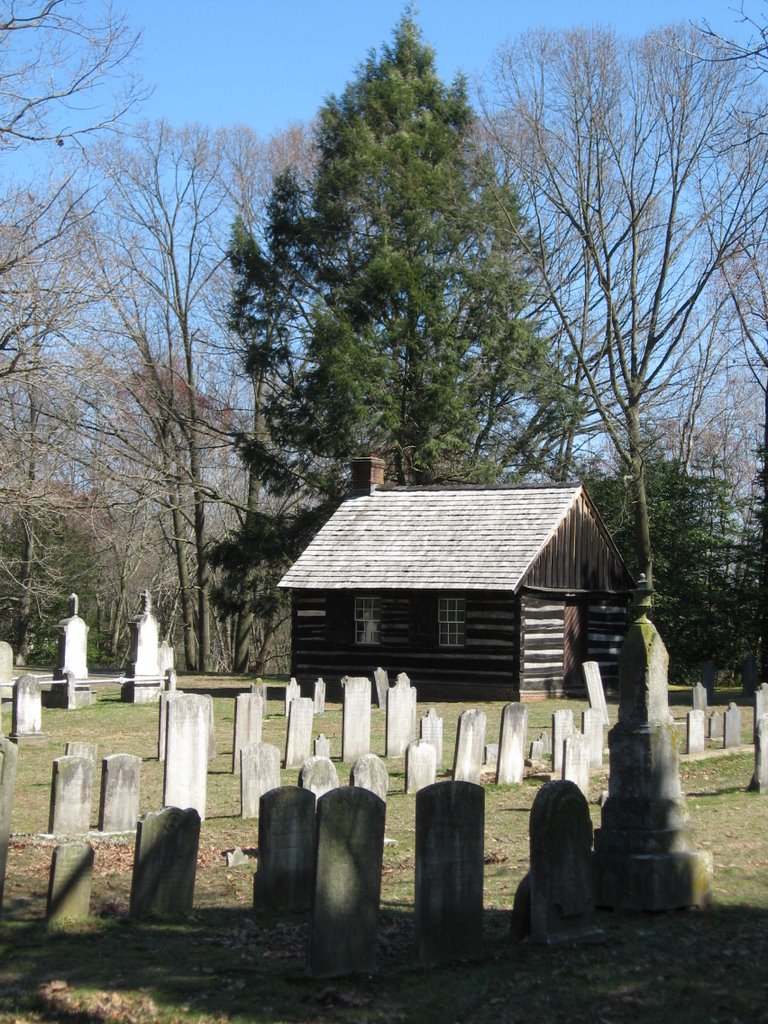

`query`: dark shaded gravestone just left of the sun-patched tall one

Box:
[253,785,315,911]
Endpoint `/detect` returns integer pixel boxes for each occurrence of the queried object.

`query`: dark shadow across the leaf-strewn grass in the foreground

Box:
[0,906,768,1024]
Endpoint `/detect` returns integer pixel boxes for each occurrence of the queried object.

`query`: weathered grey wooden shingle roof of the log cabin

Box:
[280,485,584,590]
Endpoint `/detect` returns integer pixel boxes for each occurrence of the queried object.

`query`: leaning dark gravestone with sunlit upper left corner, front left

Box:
[129,807,200,921]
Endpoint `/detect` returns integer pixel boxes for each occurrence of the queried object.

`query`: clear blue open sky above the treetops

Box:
[117,0,761,136]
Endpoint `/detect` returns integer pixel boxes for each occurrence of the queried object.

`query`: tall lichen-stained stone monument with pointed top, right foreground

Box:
[594,577,712,910]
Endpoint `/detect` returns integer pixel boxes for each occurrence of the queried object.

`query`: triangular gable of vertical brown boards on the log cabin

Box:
[522,494,632,593]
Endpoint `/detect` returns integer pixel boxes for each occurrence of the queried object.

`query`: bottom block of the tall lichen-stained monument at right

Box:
[593,843,713,910]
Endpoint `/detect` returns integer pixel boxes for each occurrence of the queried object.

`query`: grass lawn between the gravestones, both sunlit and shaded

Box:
[0,677,768,1024]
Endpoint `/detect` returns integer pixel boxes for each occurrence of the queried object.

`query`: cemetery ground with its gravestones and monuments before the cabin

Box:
[0,581,768,1024]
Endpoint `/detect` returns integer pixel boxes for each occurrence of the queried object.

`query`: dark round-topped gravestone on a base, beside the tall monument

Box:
[513,780,603,944]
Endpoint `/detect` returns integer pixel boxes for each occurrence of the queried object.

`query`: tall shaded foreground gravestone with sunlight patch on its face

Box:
[306,786,386,978]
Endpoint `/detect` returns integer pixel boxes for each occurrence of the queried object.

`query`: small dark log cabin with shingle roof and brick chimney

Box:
[280,458,633,700]
